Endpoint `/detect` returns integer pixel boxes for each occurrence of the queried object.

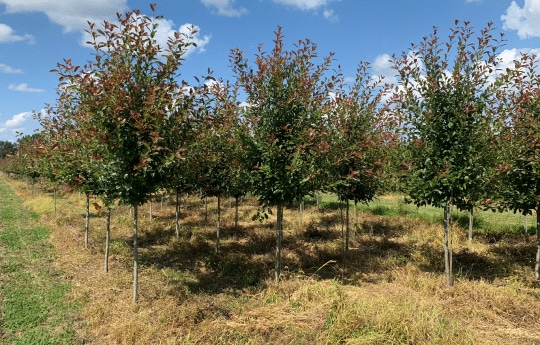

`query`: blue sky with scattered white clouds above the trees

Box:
[0,0,540,142]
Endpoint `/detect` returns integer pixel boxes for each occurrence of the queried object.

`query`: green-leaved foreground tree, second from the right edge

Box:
[393,21,501,285]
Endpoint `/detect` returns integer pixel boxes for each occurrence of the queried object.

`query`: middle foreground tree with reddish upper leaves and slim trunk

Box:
[231,28,332,282]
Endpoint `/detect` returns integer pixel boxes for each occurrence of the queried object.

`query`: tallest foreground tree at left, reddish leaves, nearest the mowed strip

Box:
[52,5,192,303]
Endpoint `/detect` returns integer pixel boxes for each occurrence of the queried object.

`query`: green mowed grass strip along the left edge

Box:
[0,176,76,345]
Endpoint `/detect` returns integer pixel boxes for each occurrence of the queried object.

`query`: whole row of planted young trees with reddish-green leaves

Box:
[2,6,540,300]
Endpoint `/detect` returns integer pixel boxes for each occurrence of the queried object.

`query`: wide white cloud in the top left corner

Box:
[0,0,128,32]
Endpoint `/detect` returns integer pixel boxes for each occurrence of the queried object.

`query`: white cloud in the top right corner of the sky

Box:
[501,0,540,39]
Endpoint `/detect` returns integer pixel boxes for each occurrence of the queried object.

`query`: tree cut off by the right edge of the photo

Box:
[497,54,540,280]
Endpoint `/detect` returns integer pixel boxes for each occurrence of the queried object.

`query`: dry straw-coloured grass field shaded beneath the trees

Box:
[0,177,540,345]
